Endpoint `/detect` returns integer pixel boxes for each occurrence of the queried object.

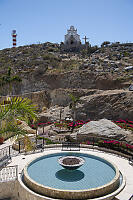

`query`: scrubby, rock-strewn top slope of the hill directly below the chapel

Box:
[0,42,133,81]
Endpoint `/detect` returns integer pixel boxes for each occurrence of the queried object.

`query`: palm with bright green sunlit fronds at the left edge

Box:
[0,97,37,140]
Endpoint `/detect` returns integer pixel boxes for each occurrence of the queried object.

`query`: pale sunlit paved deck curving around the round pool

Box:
[0,141,133,200]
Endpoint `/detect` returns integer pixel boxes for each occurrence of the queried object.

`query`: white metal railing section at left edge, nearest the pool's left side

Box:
[0,165,18,182]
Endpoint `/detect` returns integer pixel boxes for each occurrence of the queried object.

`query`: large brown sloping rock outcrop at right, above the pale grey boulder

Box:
[76,90,133,120]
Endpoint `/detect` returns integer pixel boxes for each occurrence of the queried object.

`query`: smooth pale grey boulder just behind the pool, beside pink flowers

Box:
[77,119,130,140]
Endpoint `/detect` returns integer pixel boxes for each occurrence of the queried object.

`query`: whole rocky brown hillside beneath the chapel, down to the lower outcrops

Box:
[0,43,133,122]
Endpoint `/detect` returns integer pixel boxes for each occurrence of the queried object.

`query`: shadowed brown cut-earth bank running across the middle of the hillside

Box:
[0,69,127,96]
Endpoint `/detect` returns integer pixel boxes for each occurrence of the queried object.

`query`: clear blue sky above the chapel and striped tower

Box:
[0,0,133,49]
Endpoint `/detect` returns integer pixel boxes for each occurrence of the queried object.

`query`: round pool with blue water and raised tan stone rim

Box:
[24,152,120,199]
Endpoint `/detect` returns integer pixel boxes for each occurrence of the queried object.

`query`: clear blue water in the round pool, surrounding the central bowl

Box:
[27,152,116,190]
